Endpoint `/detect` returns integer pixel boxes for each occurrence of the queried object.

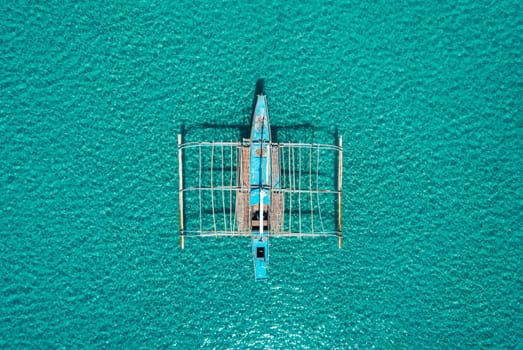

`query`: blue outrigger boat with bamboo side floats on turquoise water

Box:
[178,94,343,281]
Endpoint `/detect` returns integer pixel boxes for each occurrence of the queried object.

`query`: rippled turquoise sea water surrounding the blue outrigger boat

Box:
[0,1,523,349]
